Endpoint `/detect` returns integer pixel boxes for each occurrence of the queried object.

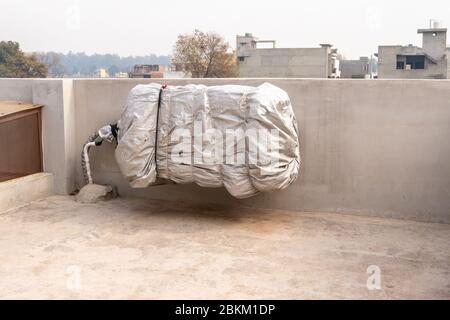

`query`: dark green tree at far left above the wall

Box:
[0,41,48,78]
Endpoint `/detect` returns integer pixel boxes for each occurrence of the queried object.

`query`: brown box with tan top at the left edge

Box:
[0,101,42,182]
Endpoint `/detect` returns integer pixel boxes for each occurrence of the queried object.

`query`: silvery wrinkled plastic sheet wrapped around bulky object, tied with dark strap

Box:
[116,83,300,198]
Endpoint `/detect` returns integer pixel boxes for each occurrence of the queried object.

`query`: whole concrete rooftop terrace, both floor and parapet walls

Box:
[0,79,450,299]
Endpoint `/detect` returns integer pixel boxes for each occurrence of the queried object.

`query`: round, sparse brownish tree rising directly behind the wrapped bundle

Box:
[172,30,237,78]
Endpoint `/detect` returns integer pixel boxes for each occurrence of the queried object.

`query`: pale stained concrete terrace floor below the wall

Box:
[0,196,450,299]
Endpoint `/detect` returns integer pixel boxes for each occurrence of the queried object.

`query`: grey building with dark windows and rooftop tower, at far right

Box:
[378,21,450,79]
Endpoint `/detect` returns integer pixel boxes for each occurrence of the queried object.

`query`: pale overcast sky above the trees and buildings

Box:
[0,0,450,58]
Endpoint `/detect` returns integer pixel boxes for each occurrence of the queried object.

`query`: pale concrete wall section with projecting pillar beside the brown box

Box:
[0,79,74,194]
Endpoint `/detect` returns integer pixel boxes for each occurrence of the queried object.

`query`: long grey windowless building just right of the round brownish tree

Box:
[236,33,339,78]
